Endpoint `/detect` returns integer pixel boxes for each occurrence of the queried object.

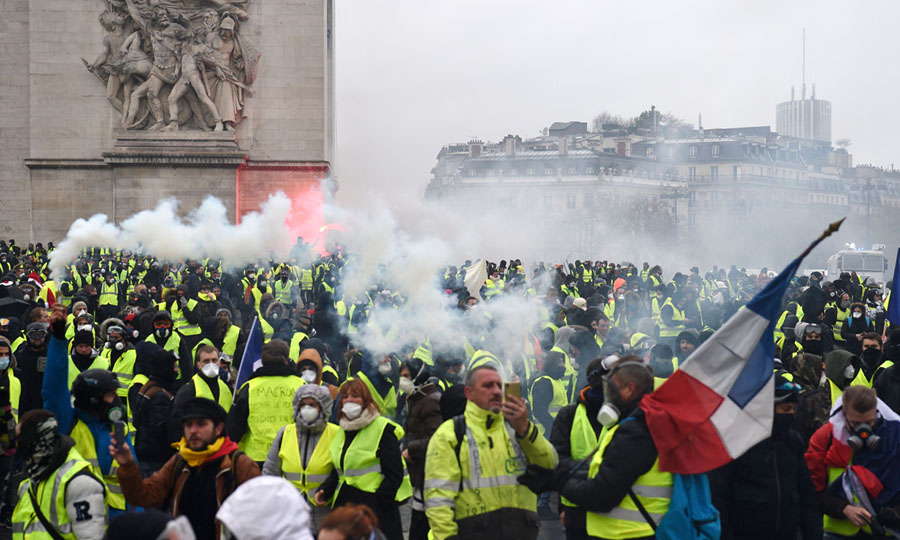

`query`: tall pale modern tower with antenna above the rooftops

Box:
[775,30,831,142]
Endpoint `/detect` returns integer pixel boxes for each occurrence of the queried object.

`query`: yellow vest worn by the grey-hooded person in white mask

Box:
[278,423,341,501]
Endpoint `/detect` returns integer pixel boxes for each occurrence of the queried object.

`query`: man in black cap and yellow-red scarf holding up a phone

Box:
[109,398,259,540]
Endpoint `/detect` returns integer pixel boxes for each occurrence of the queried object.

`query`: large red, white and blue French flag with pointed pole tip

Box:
[640,220,843,474]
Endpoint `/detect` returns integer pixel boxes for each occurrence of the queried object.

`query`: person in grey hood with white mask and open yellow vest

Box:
[263,384,340,532]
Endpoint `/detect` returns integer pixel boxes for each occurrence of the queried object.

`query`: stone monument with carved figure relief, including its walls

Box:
[0,0,336,243]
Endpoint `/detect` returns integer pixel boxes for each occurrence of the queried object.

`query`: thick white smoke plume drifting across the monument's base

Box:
[50,192,293,277]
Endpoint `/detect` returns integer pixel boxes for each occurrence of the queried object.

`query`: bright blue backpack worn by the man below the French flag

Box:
[628,474,722,540]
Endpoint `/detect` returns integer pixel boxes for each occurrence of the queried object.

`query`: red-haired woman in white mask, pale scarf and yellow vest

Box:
[314,379,412,540]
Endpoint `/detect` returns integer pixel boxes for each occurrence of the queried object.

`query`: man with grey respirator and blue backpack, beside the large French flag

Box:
[520,356,673,540]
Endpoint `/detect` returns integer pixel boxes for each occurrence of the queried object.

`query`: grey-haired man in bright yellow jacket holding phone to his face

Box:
[425,364,558,540]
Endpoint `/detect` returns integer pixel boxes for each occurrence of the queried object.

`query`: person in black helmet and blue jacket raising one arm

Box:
[41,304,134,516]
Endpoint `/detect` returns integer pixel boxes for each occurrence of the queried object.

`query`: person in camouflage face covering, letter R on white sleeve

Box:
[12,409,107,540]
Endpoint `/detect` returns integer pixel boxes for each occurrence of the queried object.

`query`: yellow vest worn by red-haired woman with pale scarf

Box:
[330,416,412,501]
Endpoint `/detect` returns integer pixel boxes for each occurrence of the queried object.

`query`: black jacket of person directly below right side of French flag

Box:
[709,431,822,540]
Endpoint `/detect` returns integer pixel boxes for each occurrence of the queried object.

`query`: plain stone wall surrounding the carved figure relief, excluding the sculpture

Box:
[0,0,333,244]
